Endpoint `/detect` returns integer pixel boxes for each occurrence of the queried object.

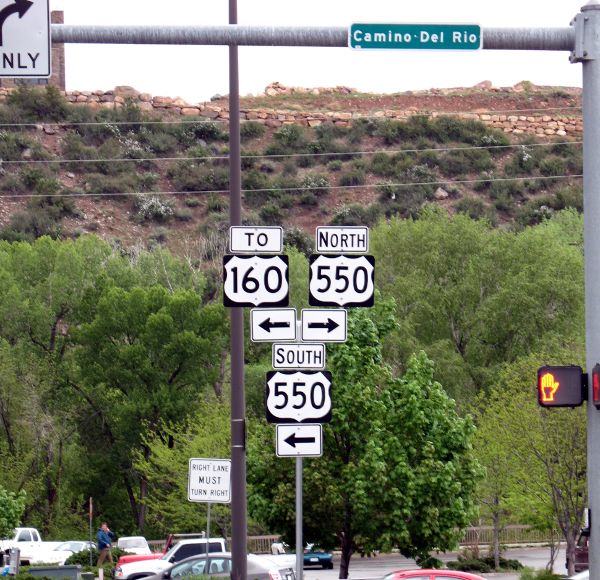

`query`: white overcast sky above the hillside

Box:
[50,0,586,103]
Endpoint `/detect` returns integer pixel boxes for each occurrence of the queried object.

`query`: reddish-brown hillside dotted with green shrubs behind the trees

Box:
[0,83,582,256]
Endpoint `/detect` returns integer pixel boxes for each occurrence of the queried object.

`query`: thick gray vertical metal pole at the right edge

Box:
[571,3,600,578]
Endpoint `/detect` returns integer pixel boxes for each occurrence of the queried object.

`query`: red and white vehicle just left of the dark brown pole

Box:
[113,538,227,580]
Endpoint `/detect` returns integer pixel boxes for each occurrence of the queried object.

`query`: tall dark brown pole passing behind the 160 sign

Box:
[229,0,248,580]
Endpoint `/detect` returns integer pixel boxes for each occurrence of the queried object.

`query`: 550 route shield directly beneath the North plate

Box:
[308,254,375,306]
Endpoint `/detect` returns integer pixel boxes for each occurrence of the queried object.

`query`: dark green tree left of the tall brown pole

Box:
[70,286,227,530]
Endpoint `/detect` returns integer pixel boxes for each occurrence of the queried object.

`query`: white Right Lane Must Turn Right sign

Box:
[188,459,231,503]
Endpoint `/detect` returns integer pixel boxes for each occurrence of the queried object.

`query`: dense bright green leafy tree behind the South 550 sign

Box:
[248,301,480,578]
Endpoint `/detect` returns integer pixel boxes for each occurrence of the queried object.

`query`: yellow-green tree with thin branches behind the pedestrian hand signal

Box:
[476,348,587,574]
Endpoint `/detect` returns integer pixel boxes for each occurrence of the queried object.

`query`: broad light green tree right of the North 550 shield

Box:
[371,208,583,404]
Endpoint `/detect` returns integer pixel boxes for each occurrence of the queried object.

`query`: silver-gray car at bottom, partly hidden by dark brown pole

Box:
[145,552,296,580]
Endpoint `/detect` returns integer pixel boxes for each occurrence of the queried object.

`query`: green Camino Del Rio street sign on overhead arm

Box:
[348,23,481,50]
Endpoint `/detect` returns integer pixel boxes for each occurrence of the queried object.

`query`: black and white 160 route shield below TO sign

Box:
[223,254,289,306]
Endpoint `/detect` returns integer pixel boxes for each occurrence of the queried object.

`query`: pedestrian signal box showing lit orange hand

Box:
[537,365,584,407]
